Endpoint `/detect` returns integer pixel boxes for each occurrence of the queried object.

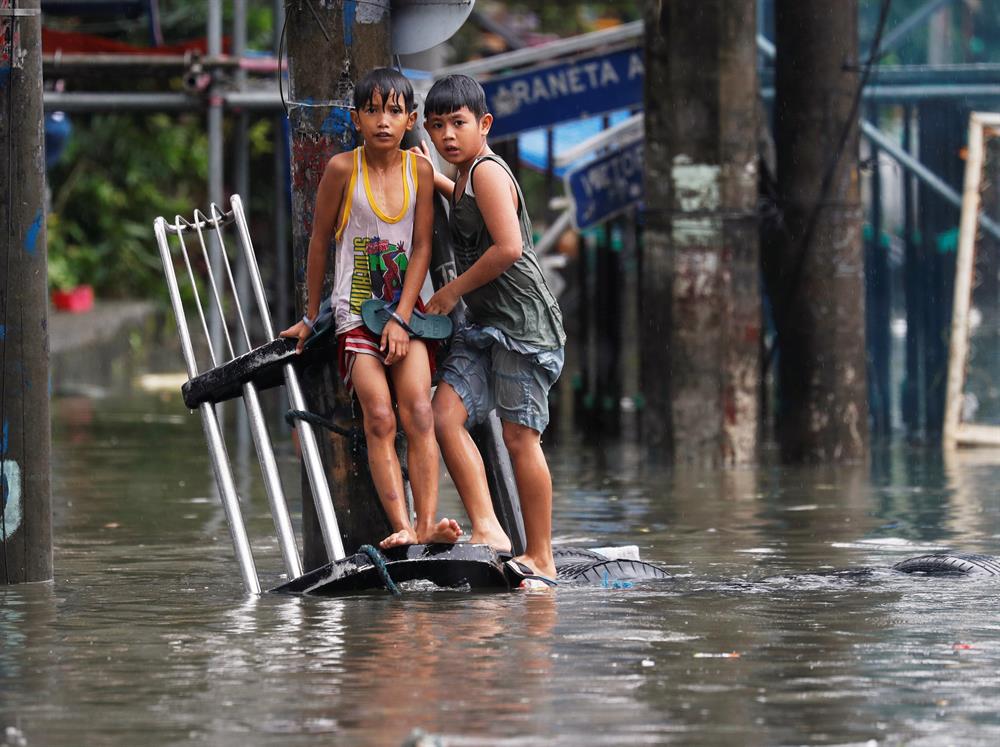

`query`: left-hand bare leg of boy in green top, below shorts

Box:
[434,383,520,552]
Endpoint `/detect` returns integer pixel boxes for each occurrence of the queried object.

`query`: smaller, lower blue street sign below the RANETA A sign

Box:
[566,139,643,229]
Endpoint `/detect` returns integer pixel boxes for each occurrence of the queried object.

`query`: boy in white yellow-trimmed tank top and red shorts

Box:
[281,68,462,548]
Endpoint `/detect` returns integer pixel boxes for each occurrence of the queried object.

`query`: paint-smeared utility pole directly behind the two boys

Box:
[286,0,391,569]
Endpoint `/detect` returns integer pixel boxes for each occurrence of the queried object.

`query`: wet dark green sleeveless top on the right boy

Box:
[448,154,566,350]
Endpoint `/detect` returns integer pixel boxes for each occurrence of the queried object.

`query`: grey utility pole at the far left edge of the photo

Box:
[0,0,52,584]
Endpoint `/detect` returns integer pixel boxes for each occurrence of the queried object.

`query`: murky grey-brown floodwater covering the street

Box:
[0,386,1000,747]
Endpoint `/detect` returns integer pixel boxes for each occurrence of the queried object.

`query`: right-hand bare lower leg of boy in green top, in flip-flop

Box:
[502,420,556,578]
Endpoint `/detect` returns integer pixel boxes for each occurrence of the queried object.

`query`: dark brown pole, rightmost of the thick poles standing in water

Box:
[765,0,868,461]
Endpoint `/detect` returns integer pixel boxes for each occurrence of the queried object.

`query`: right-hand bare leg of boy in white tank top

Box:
[389,340,462,543]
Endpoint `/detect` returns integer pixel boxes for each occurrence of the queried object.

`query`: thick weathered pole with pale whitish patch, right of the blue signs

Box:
[640,0,761,464]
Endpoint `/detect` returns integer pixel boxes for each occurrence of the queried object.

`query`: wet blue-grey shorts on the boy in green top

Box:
[440,323,564,433]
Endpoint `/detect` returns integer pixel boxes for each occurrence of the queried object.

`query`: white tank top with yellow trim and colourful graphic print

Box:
[333,147,417,335]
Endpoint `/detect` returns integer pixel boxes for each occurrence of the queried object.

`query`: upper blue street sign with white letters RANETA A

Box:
[483,47,644,137]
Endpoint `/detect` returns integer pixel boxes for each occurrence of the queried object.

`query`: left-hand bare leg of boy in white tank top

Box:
[351,354,417,548]
